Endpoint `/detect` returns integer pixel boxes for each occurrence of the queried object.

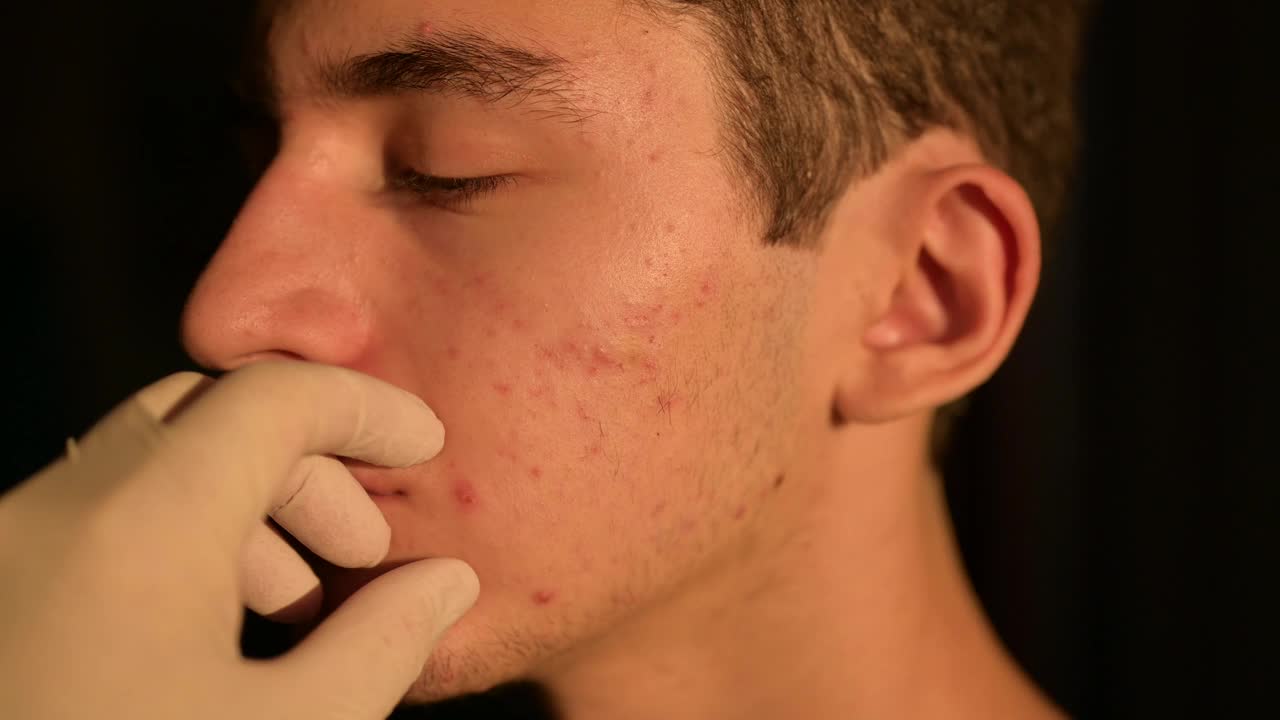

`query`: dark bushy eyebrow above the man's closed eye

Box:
[296,32,588,120]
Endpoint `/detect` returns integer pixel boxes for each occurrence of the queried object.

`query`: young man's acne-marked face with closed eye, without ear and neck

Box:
[186,0,823,697]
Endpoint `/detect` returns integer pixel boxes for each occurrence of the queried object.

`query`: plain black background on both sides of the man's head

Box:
[0,1,1280,717]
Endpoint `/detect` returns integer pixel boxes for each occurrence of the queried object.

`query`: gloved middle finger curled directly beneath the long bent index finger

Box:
[271,456,392,568]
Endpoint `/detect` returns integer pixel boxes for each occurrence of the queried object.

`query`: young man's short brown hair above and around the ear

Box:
[639,0,1087,242]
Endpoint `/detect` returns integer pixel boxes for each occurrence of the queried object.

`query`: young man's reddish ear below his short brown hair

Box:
[835,163,1041,423]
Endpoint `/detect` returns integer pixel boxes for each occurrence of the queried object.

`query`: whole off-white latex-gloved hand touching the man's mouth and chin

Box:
[0,363,479,720]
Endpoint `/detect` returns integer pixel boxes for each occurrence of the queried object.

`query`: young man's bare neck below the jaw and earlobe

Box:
[535,419,1057,720]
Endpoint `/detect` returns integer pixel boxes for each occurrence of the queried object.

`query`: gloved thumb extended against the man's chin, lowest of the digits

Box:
[270,559,480,720]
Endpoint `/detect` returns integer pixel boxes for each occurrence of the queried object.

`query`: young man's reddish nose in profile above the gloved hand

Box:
[182,159,378,370]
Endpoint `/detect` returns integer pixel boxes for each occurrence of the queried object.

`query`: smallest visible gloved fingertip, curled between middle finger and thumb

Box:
[241,523,321,624]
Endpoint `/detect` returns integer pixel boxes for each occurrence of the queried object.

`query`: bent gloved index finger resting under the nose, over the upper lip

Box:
[142,361,444,548]
